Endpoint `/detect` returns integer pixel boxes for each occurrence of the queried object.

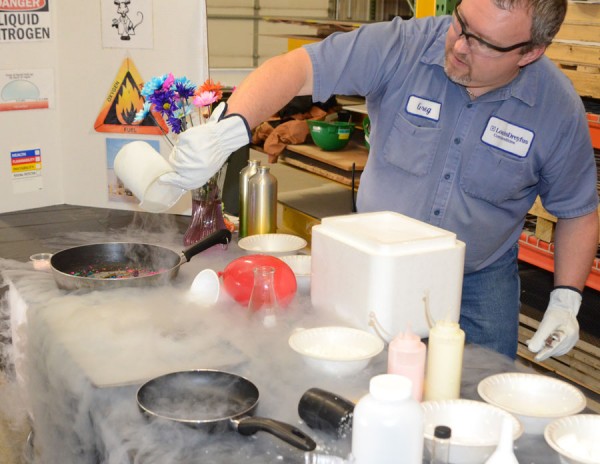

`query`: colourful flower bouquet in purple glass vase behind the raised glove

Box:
[135,73,227,246]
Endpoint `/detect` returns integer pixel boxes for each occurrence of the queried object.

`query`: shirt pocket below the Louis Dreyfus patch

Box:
[460,146,537,206]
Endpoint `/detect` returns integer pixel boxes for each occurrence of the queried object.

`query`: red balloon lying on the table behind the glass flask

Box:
[219,255,296,307]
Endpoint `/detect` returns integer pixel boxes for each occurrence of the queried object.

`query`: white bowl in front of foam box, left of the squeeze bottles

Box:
[289,326,384,376]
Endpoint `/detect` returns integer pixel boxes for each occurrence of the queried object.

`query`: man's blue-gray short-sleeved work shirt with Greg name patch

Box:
[306,16,598,273]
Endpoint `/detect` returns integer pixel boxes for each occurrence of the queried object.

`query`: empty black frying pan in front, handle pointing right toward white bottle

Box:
[137,369,316,451]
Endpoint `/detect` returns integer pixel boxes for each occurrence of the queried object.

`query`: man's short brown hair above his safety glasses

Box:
[494,0,567,49]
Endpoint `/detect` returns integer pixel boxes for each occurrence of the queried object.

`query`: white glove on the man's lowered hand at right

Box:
[527,287,581,361]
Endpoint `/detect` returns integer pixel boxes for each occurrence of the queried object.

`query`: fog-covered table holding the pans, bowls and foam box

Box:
[0,230,572,464]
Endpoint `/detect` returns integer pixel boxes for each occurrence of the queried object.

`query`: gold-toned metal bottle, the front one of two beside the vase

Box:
[248,166,277,235]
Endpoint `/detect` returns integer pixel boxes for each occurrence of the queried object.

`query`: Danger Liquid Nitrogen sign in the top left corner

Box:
[0,0,52,43]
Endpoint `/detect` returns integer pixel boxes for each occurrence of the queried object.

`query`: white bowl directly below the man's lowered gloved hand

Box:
[477,373,586,435]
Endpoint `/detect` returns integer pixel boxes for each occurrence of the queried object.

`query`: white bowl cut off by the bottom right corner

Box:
[544,414,600,464]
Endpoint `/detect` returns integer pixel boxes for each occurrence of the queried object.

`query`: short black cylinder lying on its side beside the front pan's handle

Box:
[298,388,354,438]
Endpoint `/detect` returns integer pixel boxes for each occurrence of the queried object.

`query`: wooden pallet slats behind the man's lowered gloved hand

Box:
[517,314,600,413]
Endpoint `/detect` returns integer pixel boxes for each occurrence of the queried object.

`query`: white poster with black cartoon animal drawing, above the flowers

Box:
[100,0,154,48]
